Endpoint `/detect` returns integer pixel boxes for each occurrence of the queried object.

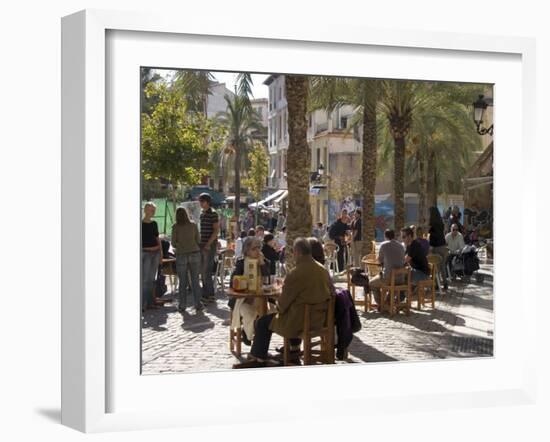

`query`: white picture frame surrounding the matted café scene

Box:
[62,10,536,432]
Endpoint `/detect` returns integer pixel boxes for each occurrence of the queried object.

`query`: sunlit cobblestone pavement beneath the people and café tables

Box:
[142,265,494,374]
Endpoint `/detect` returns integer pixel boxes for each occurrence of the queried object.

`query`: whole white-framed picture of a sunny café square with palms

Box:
[62,10,536,432]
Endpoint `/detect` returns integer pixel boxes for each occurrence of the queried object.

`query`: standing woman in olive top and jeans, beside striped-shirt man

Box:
[172,207,203,313]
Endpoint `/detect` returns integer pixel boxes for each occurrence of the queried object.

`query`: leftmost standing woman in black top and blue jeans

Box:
[141,202,162,311]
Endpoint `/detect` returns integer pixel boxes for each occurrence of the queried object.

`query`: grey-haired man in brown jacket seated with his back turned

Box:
[234,238,331,368]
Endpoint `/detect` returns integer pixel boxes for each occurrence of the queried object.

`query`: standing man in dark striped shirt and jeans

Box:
[199,193,220,302]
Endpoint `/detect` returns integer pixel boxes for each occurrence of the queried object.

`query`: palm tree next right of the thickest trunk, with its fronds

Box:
[310,77,379,255]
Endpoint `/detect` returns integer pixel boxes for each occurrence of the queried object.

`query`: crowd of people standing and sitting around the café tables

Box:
[141,193,470,368]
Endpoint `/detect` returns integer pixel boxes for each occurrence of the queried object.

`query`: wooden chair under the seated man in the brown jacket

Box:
[283,296,335,365]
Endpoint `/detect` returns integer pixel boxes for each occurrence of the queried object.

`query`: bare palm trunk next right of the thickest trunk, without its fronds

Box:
[361,91,377,256]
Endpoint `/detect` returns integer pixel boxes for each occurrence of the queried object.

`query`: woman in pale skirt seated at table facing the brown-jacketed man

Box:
[229,237,269,345]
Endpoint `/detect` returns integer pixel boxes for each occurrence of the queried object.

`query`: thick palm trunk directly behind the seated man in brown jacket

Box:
[285,75,312,267]
